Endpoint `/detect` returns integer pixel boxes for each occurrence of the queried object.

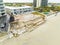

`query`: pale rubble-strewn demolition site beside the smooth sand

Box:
[10,14,45,37]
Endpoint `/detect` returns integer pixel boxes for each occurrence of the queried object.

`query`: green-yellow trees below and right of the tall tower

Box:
[34,6,60,12]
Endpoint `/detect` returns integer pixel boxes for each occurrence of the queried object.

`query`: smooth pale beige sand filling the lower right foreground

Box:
[0,14,60,45]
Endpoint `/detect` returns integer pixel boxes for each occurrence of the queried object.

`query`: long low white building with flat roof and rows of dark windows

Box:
[5,6,33,15]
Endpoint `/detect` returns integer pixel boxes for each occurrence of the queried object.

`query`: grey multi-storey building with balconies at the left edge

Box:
[0,0,8,31]
